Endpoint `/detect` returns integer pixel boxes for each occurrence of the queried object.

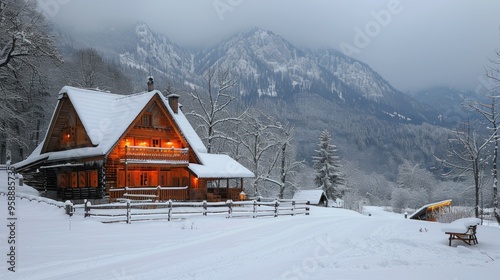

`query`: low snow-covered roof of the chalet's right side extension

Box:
[189,153,255,178]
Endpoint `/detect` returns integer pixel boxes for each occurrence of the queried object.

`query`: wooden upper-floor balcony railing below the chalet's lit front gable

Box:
[125,146,189,164]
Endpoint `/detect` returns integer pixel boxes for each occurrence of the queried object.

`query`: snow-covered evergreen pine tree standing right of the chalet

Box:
[313,129,344,199]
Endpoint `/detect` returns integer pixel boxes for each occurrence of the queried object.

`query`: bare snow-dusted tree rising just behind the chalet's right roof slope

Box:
[187,66,243,153]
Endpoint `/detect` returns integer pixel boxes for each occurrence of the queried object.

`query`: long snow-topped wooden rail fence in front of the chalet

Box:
[81,199,309,223]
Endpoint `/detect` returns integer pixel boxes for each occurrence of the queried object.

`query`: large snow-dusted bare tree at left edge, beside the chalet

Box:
[0,0,61,160]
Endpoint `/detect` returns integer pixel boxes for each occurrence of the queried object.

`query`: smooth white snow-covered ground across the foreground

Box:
[0,170,500,280]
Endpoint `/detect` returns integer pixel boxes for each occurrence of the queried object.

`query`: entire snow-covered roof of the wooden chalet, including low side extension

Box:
[16,86,250,178]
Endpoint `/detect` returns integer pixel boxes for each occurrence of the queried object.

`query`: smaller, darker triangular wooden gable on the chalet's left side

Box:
[42,95,93,154]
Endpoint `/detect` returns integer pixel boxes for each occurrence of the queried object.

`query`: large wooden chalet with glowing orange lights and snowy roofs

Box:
[14,78,254,201]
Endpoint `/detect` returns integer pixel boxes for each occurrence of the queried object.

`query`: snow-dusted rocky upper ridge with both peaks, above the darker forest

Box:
[59,23,454,125]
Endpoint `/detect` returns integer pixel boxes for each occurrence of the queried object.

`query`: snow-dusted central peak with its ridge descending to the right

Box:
[196,29,438,123]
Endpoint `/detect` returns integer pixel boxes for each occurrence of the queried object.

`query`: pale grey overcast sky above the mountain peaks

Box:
[38,0,500,91]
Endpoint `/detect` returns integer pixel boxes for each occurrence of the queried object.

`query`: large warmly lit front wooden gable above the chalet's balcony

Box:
[112,94,200,163]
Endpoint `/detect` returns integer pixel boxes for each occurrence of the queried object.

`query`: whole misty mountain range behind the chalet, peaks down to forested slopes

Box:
[54,23,467,177]
